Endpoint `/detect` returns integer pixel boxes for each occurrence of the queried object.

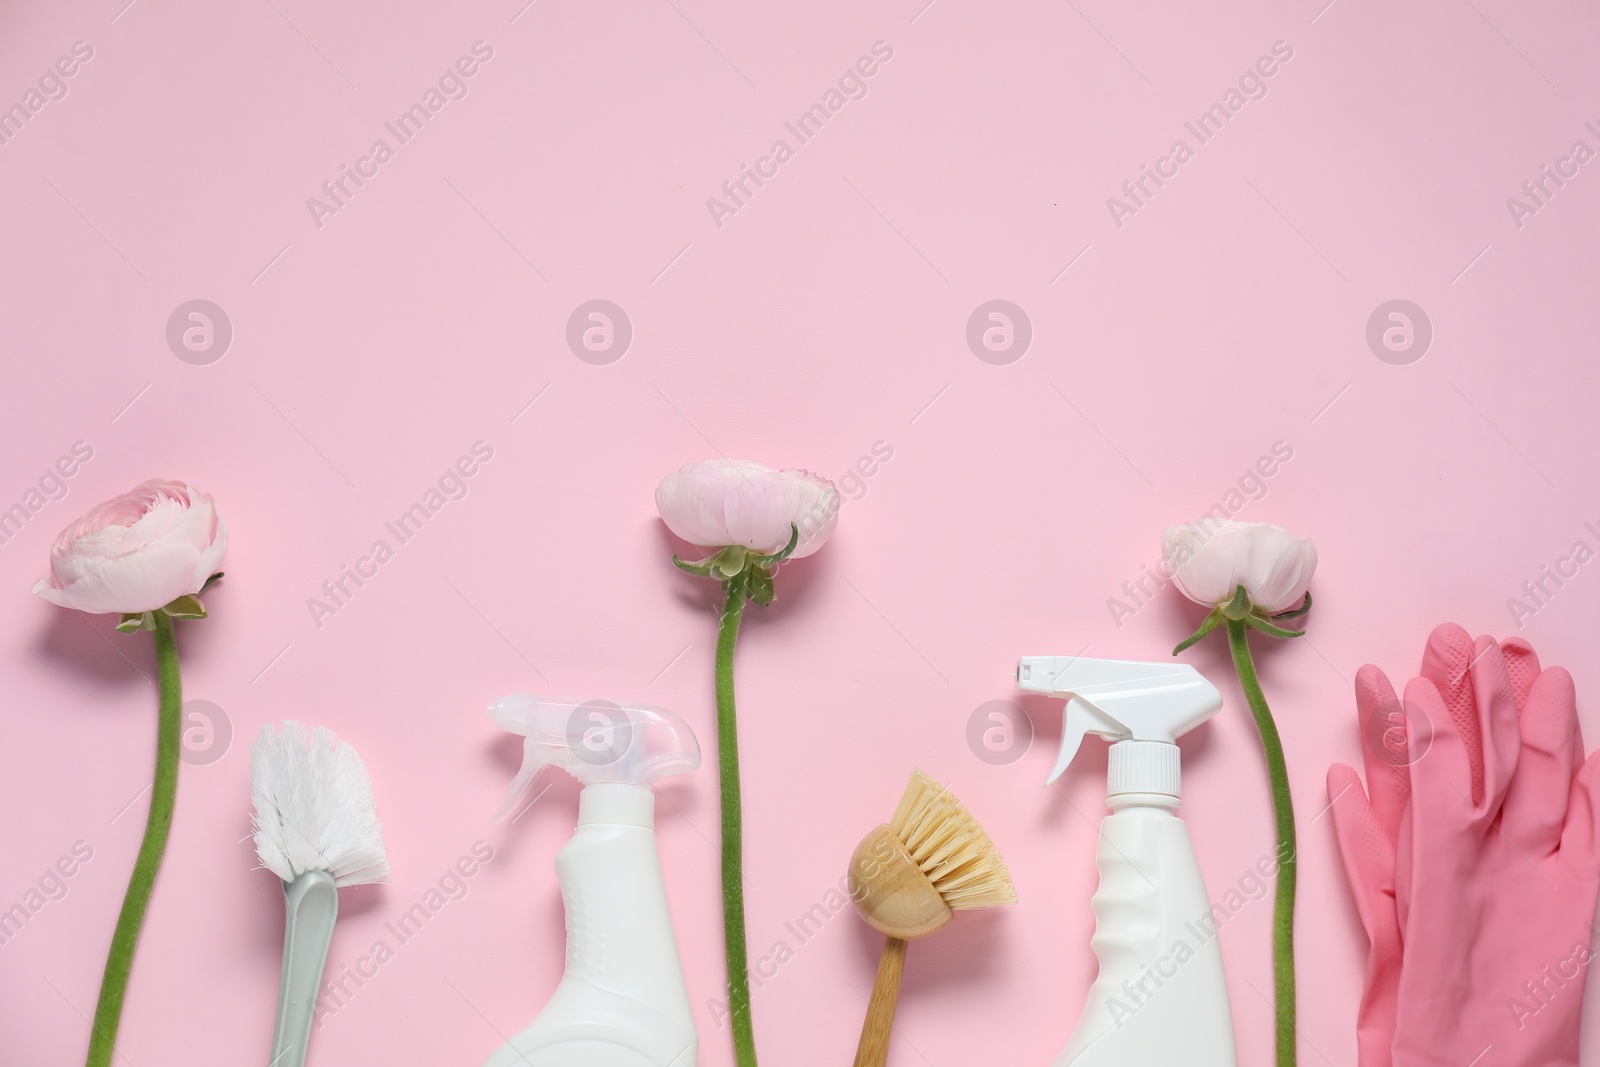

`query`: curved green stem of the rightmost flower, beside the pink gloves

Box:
[1227,619,1298,1067]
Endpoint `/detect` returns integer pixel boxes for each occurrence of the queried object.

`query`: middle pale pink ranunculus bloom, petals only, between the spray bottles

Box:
[656,459,840,560]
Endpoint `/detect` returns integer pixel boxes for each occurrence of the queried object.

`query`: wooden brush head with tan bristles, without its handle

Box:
[850,771,1016,941]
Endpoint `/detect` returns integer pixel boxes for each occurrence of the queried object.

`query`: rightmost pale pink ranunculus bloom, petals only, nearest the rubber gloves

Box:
[1162,518,1317,614]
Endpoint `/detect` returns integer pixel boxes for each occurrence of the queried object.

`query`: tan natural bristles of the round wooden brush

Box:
[890,771,1016,912]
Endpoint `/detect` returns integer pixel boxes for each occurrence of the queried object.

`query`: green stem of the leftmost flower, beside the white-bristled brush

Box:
[88,611,184,1067]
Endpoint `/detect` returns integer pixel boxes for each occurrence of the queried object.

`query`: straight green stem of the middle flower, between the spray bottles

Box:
[717,569,755,1067]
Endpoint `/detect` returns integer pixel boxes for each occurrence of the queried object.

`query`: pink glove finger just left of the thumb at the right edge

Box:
[1501,667,1582,859]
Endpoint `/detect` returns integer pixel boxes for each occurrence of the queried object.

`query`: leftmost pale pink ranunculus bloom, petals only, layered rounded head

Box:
[34,478,227,614]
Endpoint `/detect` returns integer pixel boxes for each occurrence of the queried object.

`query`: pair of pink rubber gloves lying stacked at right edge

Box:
[1328,625,1600,1067]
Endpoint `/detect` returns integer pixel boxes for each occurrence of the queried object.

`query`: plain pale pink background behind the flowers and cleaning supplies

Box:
[0,0,1600,1067]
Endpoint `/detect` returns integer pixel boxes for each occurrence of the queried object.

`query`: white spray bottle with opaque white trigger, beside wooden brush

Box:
[1016,656,1237,1067]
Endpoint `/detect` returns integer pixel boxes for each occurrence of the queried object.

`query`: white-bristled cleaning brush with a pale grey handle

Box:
[250,721,389,1067]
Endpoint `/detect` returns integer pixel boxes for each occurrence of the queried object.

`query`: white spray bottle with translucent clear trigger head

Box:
[485,694,699,1067]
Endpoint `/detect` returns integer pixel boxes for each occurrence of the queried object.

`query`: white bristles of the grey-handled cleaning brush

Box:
[250,721,389,886]
